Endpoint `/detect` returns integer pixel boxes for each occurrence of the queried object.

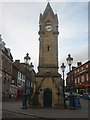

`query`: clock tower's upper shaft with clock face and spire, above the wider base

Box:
[38,3,59,73]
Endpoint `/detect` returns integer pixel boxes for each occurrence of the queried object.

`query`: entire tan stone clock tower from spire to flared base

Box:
[33,3,64,108]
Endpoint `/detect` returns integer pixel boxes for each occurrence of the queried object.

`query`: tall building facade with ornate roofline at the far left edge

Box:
[0,36,13,99]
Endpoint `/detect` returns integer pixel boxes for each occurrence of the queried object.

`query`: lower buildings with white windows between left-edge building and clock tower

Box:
[11,60,36,100]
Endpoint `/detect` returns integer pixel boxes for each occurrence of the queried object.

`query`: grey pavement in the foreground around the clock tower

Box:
[2,98,90,118]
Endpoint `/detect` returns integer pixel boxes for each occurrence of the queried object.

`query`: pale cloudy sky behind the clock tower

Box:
[0,0,88,77]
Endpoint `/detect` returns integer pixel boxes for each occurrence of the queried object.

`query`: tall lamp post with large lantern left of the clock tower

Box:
[22,53,31,109]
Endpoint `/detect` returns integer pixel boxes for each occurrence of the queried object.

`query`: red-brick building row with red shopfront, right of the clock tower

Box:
[66,60,90,94]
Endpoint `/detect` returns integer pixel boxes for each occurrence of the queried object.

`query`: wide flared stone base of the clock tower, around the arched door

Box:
[32,72,66,109]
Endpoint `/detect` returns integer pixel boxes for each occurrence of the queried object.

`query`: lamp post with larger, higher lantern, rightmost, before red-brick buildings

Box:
[66,54,73,94]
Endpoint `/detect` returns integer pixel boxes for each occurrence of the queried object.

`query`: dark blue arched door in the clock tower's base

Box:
[44,89,52,108]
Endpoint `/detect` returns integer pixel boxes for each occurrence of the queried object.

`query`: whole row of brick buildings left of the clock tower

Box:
[0,35,36,100]
